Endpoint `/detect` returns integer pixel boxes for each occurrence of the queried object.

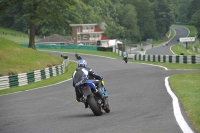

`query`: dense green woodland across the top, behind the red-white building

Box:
[0,0,200,48]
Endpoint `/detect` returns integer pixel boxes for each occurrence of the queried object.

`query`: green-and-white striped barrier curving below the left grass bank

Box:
[0,58,69,90]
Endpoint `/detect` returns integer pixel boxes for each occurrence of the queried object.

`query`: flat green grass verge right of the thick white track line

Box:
[169,73,200,132]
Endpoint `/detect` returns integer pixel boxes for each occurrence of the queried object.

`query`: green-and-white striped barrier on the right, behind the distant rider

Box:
[113,48,200,64]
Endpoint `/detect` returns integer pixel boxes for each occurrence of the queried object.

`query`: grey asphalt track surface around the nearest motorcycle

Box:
[0,25,199,133]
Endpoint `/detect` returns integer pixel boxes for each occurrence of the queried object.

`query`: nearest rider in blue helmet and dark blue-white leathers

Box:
[72,59,105,108]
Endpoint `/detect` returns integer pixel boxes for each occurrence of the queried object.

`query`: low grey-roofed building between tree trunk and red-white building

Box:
[36,34,73,44]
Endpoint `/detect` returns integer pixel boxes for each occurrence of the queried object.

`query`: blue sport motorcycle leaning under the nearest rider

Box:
[77,80,110,116]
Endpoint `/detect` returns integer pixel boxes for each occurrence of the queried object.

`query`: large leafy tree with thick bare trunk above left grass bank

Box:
[0,0,75,49]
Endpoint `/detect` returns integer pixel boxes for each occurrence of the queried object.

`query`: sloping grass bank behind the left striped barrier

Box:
[0,37,63,76]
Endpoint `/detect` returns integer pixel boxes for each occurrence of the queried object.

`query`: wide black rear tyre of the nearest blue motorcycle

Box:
[87,94,103,116]
